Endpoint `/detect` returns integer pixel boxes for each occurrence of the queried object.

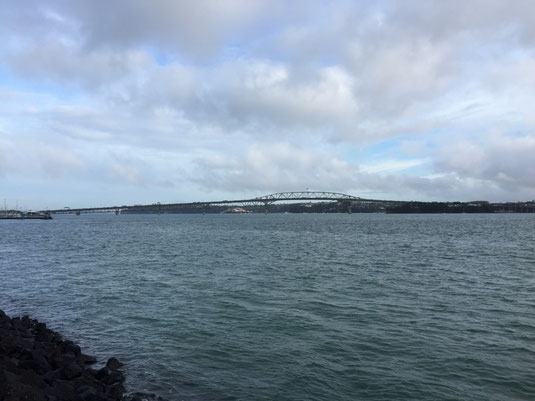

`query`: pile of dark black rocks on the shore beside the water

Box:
[0,310,164,401]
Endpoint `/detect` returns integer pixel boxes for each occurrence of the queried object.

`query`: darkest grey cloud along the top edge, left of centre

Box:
[45,0,284,58]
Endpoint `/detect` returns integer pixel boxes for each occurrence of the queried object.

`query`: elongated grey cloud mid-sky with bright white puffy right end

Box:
[114,60,358,141]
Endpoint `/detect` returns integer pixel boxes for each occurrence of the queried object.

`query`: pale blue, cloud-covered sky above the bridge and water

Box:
[0,0,535,209]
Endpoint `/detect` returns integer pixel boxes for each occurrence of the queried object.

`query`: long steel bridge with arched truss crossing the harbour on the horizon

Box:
[42,191,399,214]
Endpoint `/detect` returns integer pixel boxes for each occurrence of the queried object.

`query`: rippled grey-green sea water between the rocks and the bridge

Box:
[0,214,535,400]
